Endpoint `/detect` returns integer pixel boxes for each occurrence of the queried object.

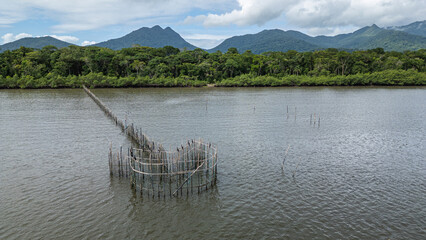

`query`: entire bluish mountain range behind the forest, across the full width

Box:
[0,21,426,53]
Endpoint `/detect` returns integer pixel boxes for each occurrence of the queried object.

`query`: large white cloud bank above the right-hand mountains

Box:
[189,0,426,33]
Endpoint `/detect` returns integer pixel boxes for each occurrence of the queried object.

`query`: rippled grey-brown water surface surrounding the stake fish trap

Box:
[0,88,426,239]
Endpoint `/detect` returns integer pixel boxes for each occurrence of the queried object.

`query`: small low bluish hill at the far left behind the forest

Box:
[0,36,73,52]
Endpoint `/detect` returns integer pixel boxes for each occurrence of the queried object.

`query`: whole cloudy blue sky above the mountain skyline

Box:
[0,0,426,49]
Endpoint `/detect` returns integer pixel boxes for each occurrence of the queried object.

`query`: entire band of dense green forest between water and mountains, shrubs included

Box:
[0,46,426,88]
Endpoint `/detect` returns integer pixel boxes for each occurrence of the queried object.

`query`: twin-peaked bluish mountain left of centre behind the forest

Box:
[94,26,196,50]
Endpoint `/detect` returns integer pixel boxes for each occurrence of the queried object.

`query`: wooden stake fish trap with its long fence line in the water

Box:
[83,86,218,198]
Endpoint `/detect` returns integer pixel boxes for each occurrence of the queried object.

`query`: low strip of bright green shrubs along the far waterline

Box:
[0,70,426,89]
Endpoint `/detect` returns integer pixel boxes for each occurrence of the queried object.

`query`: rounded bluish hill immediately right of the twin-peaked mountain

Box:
[209,29,321,54]
